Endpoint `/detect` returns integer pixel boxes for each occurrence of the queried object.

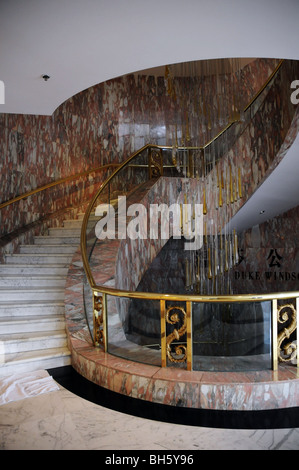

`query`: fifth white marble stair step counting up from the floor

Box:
[0,287,64,305]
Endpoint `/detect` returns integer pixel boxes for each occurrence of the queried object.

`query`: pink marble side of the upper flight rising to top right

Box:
[197,62,299,241]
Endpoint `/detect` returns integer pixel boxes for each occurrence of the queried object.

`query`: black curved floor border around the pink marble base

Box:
[48,366,299,429]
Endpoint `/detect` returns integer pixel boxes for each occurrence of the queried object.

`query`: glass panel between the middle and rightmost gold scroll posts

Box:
[192,301,271,372]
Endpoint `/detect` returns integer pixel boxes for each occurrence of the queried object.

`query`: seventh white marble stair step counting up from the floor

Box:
[0,263,69,276]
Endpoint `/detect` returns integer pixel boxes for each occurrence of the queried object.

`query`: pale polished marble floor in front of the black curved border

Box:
[0,366,299,450]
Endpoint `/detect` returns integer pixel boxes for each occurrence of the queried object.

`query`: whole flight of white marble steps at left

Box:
[0,214,83,377]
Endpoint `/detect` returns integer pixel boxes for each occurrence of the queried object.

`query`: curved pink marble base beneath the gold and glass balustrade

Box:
[65,246,299,411]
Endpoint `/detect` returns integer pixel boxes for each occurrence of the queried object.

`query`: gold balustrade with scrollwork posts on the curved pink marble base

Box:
[93,287,299,371]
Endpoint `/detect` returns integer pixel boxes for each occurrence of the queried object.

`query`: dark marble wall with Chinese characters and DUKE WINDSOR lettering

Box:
[232,206,299,294]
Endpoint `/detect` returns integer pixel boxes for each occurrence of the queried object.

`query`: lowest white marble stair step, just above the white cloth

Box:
[0,348,71,377]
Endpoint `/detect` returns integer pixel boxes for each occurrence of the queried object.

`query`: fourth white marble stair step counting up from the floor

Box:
[0,300,65,319]
